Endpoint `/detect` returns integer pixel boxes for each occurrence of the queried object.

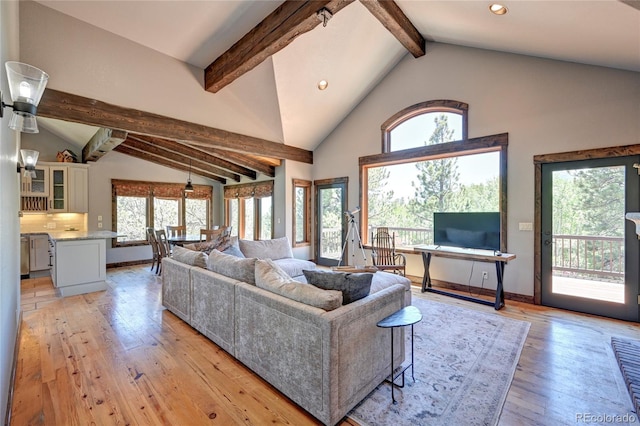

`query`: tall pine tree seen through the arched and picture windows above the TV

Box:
[409,114,460,224]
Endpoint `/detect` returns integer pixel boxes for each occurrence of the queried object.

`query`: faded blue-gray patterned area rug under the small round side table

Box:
[348,296,531,426]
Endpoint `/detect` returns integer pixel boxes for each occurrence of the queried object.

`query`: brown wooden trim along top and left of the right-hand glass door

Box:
[533,144,640,305]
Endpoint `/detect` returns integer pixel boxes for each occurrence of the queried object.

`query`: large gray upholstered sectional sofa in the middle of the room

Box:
[162,239,411,425]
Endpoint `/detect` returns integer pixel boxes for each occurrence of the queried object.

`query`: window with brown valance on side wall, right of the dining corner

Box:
[224,180,273,240]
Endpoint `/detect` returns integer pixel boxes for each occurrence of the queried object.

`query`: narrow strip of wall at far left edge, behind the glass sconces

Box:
[0,1,20,421]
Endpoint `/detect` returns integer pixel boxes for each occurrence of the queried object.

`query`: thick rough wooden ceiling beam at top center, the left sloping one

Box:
[204,0,354,93]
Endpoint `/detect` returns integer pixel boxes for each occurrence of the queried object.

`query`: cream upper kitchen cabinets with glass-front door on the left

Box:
[21,163,89,213]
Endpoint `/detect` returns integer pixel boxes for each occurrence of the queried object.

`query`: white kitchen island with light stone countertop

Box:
[49,231,118,296]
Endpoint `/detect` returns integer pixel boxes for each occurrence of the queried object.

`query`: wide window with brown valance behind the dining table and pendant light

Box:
[111,179,213,246]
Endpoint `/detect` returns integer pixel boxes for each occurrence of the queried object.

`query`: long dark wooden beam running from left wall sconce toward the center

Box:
[38,88,313,164]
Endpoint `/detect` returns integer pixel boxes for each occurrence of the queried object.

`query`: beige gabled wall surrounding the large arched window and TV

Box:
[313,43,640,295]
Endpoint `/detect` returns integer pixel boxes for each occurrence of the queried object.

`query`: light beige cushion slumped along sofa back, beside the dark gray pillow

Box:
[255,259,342,311]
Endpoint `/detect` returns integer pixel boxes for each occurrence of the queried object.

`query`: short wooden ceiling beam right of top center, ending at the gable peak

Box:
[360,0,425,58]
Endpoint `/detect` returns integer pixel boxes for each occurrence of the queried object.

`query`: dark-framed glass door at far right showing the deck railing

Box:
[541,157,640,320]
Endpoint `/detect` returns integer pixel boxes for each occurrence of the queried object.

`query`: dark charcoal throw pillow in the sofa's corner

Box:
[302,270,373,305]
